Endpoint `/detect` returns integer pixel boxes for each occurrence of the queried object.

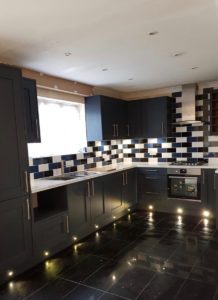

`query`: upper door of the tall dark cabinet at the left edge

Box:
[0,66,28,201]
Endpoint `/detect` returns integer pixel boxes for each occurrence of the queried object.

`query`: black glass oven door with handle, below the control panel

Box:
[168,175,201,202]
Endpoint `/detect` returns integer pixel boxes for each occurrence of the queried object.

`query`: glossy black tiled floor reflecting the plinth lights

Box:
[0,212,218,300]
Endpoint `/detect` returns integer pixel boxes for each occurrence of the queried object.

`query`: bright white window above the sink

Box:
[28,97,86,157]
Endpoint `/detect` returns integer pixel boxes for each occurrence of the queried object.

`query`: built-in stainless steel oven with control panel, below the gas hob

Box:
[167,168,201,202]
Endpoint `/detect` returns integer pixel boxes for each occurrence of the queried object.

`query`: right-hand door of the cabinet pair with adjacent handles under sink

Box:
[90,177,105,225]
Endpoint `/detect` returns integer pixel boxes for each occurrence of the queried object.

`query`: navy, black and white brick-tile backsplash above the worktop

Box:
[29,89,218,179]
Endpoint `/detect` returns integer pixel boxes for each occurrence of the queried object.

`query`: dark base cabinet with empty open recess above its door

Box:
[31,186,70,261]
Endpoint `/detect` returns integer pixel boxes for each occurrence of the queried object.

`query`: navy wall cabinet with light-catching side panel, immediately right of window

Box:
[85,96,128,141]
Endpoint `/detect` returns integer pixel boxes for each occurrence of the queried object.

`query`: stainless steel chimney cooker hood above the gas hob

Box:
[176,84,202,125]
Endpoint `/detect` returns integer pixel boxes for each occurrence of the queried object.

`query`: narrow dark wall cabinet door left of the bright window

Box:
[23,78,41,143]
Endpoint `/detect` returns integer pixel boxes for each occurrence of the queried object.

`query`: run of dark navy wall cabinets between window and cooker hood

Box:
[85,96,171,141]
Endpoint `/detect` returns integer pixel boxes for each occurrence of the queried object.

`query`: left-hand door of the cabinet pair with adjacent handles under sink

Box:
[67,181,90,238]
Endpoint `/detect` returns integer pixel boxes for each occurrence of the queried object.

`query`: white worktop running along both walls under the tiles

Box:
[31,162,218,194]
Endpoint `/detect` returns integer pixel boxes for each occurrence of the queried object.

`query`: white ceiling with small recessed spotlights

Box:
[0,0,218,91]
